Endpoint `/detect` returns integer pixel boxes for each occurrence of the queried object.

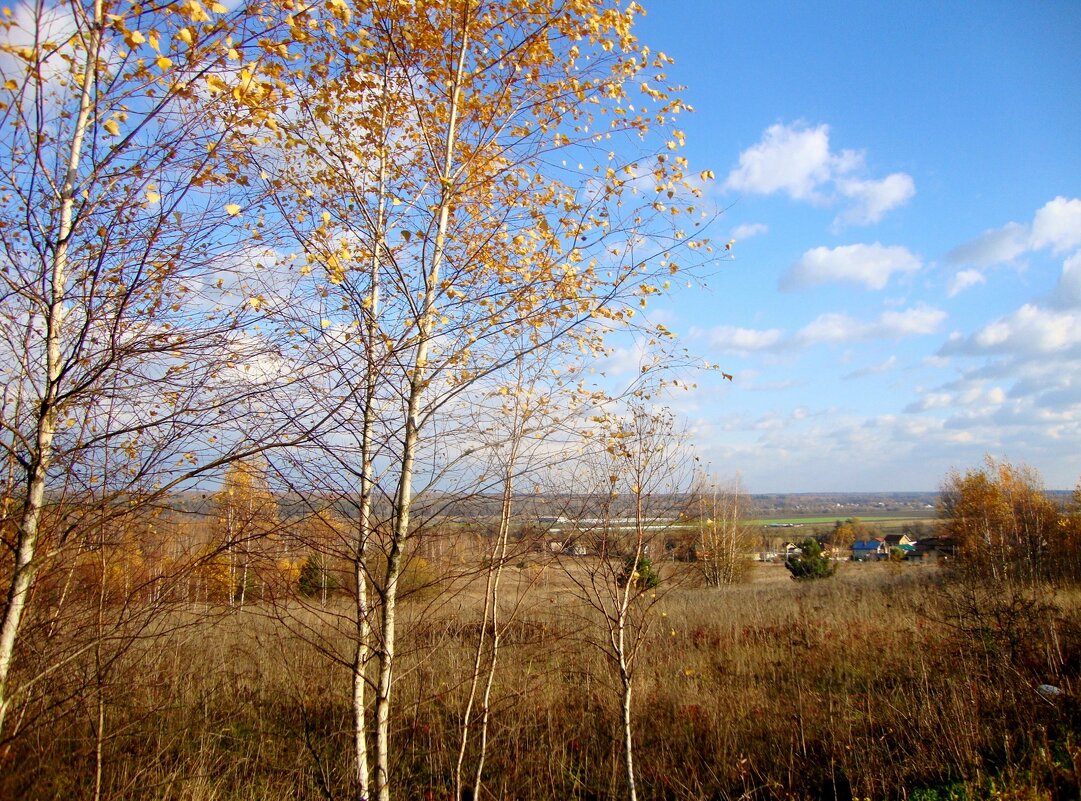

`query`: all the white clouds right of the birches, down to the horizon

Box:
[674,117,1081,490]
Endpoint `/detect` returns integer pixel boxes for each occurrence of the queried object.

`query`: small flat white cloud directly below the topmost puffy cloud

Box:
[780,242,922,291]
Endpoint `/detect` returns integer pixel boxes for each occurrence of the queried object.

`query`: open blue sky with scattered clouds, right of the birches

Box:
[638,0,1081,492]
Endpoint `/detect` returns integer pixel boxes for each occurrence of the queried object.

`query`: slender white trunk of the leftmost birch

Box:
[0,0,104,733]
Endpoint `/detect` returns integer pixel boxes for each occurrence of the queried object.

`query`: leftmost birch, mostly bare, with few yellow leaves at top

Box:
[0,0,309,730]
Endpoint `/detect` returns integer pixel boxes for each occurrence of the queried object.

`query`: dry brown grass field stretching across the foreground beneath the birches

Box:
[0,564,1081,801]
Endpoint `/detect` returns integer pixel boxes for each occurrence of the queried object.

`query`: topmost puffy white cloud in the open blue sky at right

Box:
[724,122,916,228]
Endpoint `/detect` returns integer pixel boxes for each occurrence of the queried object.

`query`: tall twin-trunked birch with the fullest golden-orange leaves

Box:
[245,0,709,799]
